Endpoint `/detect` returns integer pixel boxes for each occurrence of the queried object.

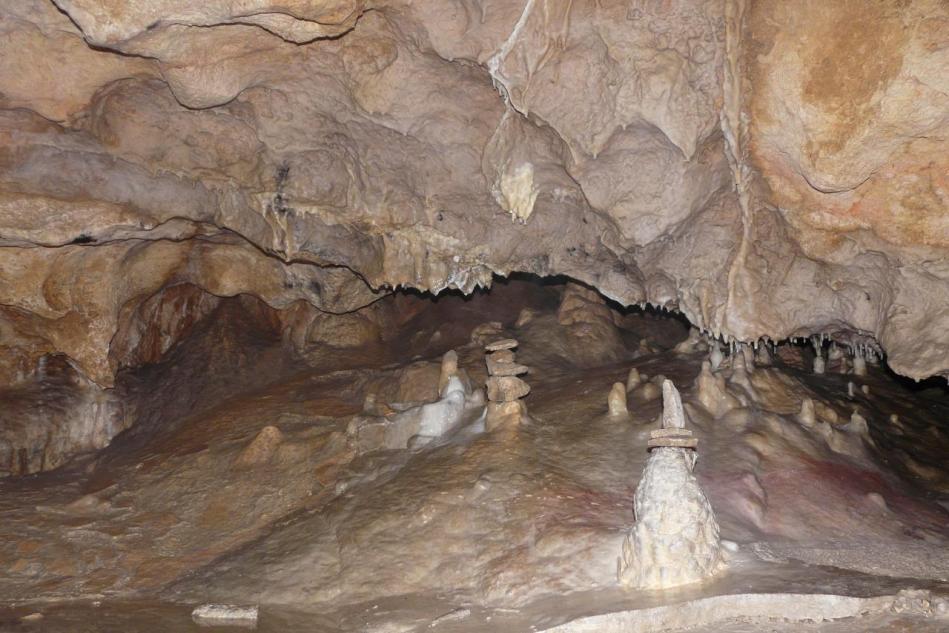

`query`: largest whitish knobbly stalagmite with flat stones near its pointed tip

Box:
[617,380,725,589]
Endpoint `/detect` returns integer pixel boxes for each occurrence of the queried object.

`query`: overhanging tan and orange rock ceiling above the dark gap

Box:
[0,0,949,386]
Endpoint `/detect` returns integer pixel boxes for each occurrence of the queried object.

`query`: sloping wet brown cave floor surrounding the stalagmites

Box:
[0,304,949,631]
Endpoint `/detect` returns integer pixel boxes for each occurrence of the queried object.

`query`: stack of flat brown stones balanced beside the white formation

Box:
[484,338,531,431]
